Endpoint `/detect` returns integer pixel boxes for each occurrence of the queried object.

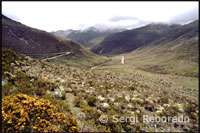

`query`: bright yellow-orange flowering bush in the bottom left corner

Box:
[2,94,78,132]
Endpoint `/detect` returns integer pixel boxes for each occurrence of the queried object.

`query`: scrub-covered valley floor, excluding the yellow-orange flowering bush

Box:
[2,47,199,132]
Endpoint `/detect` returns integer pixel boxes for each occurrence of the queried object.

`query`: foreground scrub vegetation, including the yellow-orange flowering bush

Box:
[2,49,199,132]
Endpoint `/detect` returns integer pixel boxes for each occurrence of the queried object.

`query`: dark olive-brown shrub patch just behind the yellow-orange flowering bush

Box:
[2,71,58,96]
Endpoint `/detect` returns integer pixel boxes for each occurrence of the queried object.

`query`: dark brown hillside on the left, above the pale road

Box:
[2,15,106,67]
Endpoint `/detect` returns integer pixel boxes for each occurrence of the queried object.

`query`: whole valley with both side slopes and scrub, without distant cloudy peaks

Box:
[2,14,199,132]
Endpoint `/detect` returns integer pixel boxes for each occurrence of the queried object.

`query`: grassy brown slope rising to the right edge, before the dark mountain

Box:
[120,21,199,77]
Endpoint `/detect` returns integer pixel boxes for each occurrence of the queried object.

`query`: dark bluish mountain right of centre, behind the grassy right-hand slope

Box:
[91,24,180,55]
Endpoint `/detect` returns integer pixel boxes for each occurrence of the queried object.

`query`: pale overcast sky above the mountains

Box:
[2,1,199,32]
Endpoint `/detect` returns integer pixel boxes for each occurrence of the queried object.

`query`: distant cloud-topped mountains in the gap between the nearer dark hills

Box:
[51,27,123,48]
